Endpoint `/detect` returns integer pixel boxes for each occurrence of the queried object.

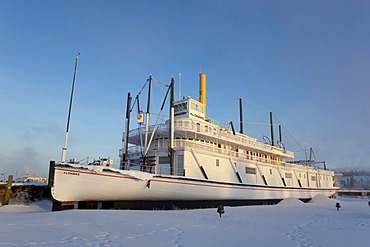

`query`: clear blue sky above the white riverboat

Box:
[0,0,370,179]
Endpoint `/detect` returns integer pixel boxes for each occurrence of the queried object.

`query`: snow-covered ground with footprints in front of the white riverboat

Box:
[0,197,370,247]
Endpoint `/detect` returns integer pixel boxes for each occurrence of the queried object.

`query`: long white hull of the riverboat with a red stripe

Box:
[52,167,336,208]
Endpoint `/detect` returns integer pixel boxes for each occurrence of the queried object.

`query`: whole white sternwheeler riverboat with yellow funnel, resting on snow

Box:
[52,75,338,206]
